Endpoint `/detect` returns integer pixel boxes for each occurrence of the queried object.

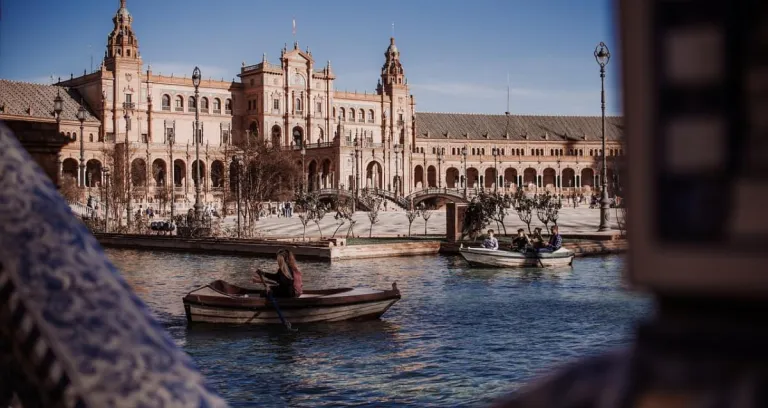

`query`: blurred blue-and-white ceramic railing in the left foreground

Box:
[0,123,226,407]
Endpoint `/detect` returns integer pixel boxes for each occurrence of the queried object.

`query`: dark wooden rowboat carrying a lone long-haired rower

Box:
[183,280,400,325]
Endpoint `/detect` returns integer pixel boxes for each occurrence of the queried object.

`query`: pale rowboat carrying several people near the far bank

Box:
[459,245,575,268]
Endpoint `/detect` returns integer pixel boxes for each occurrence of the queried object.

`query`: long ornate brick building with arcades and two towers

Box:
[0,0,623,214]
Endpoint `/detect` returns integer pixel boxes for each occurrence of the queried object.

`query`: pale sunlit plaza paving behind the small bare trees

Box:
[218,207,618,238]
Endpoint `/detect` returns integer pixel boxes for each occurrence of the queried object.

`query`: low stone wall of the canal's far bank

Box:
[95,234,628,261]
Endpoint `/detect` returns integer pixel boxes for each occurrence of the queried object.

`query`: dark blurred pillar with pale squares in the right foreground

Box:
[496,0,768,407]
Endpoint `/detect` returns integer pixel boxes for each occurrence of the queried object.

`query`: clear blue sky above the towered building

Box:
[0,0,621,115]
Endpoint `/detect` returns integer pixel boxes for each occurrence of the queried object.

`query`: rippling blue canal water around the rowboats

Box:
[107,250,650,407]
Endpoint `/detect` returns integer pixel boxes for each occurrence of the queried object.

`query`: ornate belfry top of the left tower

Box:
[104,0,141,71]
